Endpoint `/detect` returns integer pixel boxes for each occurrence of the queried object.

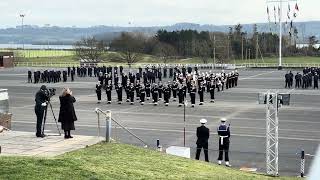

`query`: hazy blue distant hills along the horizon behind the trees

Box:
[0,21,320,45]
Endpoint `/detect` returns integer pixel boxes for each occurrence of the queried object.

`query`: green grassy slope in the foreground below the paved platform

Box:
[0,143,297,180]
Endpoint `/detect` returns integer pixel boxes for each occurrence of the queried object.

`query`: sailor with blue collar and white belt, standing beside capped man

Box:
[217,118,231,167]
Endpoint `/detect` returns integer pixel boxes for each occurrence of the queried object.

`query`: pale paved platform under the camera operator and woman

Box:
[0,131,99,157]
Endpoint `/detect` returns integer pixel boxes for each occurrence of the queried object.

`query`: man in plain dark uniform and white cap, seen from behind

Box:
[196,119,210,162]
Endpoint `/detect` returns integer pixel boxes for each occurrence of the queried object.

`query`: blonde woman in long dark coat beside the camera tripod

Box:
[58,88,77,139]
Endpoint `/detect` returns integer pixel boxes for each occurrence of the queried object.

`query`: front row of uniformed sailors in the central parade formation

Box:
[96,76,235,107]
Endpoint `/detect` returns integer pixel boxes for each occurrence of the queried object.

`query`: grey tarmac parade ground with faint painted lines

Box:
[0,68,320,176]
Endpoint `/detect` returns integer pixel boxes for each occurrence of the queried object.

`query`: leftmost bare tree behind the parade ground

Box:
[74,37,107,62]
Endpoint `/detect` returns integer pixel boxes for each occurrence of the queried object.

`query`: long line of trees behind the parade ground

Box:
[74,24,320,65]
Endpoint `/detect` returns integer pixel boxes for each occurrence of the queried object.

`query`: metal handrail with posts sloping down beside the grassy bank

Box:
[95,108,148,147]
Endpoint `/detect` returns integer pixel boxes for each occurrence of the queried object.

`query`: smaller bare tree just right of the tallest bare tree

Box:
[153,42,177,64]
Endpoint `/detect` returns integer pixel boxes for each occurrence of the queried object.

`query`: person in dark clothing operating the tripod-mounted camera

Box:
[34,85,48,137]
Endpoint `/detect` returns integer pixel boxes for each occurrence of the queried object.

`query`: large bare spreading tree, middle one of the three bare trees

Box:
[111,33,145,68]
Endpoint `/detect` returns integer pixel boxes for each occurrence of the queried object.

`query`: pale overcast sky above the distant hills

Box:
[0,0,320,28]
